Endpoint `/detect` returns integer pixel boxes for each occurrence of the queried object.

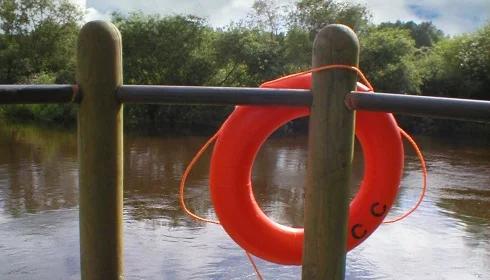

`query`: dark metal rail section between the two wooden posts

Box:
[117,85,312,106]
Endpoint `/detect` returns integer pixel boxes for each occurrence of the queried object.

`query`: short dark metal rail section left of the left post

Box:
[0,85,79,104]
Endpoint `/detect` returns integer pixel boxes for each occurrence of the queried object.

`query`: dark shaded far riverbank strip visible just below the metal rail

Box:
[0,104,490,141]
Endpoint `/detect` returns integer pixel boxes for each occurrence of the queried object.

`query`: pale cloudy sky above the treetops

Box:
[73,0,490,35]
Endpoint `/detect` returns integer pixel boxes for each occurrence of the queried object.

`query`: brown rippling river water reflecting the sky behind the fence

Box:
[0,124,490,279]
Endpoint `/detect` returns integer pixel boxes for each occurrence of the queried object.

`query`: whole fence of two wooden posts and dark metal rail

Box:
[0,21,490,279]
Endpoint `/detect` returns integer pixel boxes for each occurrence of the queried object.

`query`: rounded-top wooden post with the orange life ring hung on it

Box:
[302,24,359,280]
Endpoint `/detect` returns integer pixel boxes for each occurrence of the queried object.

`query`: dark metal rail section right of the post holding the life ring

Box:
[345,92,490,122]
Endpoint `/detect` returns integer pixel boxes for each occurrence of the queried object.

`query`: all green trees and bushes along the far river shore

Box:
[0,0,490,136]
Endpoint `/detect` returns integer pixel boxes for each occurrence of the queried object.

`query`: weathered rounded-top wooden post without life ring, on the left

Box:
[77,21,124,279]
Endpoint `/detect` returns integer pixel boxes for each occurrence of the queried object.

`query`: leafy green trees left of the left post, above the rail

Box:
[0,0,83,83]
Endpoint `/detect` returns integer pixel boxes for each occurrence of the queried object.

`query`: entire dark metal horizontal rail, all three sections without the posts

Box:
[0,85,490,122]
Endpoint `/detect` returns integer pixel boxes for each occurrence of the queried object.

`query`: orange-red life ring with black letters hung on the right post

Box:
[210,74,403,265]
